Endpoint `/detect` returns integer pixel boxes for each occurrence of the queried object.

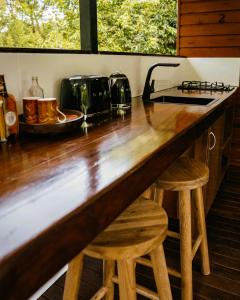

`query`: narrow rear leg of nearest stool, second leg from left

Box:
[103,260,115,300]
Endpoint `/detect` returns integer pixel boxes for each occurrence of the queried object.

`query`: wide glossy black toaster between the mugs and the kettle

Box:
[60,75,111,116]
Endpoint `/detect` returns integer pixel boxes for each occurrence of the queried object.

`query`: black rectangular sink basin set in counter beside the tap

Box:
[150,96,217,106]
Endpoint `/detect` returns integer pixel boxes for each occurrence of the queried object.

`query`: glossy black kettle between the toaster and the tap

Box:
[109,72,132,106]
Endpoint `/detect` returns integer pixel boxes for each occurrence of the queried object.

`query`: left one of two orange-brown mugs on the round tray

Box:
[23,97,39,124]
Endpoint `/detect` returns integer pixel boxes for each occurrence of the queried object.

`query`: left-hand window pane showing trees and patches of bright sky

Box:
[0,0,80,49]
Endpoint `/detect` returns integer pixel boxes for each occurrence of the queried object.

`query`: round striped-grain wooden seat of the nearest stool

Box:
[84,197,168,260]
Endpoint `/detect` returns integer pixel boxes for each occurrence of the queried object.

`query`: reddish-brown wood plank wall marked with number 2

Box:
[178,0,240,57]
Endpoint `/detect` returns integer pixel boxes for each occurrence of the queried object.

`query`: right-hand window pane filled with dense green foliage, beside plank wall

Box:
[97,0,177,55]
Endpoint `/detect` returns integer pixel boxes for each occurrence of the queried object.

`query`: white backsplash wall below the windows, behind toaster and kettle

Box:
[0,53,186,110]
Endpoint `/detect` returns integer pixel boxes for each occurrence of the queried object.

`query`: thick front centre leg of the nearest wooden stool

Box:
[117,259,137,300]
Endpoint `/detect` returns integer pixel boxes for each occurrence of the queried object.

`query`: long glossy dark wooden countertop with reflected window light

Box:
[0,88,234,300]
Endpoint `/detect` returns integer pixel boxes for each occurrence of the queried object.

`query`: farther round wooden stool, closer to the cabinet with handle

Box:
[155,157,210,300]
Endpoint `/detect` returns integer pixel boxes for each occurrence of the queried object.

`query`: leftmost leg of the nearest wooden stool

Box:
[63,253,84,300]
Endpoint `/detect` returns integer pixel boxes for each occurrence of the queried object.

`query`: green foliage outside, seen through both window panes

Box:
[0,0,177,55]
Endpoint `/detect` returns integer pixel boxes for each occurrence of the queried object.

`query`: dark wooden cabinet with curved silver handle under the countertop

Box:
[145,91,234,218]
